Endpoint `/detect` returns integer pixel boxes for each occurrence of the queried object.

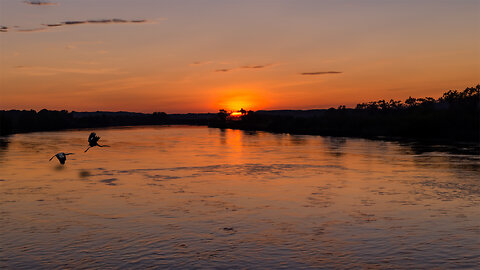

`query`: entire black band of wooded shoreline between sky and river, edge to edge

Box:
[0,85,480,143]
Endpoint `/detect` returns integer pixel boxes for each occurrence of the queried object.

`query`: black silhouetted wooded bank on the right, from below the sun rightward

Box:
[210,85,480,142]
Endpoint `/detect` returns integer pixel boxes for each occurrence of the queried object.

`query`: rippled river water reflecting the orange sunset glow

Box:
[0,127,480,269]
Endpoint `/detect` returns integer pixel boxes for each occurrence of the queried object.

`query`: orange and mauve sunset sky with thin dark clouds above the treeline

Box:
[0,0,480,113]
